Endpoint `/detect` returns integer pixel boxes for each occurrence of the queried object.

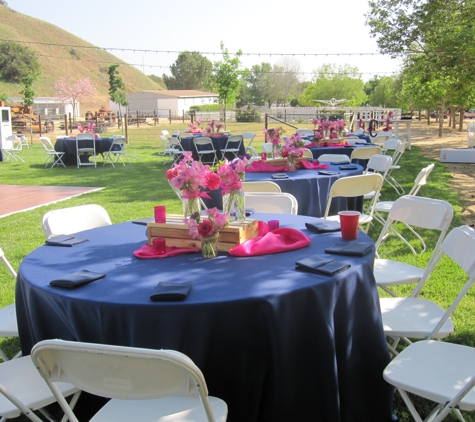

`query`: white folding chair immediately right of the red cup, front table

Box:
[374,195,453,296]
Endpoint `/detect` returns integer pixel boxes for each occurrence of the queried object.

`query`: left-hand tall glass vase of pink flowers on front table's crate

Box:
[166,151,220,219]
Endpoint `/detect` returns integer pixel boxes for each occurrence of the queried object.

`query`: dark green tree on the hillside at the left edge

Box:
[0,41,40,83]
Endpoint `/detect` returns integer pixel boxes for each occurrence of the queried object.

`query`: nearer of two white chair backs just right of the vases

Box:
[244,192,298,215]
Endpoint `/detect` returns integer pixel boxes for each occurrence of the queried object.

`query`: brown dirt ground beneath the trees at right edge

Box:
[411,120,475,225]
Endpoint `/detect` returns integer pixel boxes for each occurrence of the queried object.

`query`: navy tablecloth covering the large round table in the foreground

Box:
[16,214,393,422]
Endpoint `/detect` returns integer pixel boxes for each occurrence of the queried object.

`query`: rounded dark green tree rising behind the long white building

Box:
[162,51,213,89]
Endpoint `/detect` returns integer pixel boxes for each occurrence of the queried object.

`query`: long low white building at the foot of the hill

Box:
[109,89,219,116]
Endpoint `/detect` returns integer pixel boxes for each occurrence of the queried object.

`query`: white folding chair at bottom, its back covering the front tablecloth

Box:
[31,340,227,422]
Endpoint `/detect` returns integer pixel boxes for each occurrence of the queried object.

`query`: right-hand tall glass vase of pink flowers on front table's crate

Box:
[216,157,248,222]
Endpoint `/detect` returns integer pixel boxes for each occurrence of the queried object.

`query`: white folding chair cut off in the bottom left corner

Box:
[0,356,81,422]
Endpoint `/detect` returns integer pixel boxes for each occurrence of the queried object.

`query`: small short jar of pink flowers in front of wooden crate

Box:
[185,208,229,258]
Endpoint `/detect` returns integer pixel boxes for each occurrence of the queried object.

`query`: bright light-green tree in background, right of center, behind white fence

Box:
[299,64,368,106]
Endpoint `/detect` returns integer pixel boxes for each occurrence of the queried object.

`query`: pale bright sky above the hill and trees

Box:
[7,0,399,80]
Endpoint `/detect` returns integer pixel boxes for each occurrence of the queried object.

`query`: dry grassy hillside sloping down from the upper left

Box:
[0,5,166,110]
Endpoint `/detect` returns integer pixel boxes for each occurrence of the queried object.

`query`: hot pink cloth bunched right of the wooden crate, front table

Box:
[229,228,310,256]
